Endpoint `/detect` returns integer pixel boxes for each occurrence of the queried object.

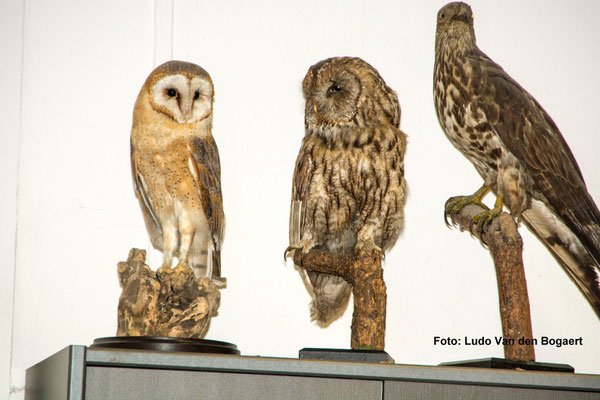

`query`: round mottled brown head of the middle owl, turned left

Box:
[302,57,400,128]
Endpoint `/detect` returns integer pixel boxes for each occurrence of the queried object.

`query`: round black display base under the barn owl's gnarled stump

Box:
[90,336,240,355]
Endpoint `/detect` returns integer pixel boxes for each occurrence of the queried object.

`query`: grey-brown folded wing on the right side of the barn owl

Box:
[187,136,225,276]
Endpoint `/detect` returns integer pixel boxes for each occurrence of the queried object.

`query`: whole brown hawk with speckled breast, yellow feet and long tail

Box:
[433,3,600,317]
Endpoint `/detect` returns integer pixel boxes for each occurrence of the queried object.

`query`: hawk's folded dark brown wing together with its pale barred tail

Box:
[470,51,600,315]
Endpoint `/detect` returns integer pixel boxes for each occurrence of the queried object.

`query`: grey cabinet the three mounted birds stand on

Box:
[25,346,600,400]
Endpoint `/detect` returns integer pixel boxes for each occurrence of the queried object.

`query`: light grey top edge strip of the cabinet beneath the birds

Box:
[77,346,600,392]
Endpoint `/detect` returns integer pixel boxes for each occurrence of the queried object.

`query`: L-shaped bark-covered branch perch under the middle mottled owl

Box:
[294,250,387,350]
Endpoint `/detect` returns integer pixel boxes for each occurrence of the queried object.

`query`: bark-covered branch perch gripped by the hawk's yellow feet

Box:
[450,204,535,361]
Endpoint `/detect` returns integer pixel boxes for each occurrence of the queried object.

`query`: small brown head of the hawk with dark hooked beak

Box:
[435,2,475,47]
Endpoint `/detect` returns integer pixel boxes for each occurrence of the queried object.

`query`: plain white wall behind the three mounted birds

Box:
[0,0,600,398]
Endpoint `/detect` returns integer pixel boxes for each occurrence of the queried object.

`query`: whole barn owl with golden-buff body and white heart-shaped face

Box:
[131,61,225,278]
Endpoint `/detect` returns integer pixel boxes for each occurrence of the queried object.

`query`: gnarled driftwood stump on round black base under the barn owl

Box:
[117,249,221,338]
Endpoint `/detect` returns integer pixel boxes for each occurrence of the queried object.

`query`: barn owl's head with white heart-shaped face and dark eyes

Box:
[140,61,214,124]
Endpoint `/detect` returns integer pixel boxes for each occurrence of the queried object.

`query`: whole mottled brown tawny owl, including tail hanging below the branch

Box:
[290,57,406,327]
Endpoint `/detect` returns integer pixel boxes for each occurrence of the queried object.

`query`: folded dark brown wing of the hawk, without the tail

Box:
[476,53,600,265]
